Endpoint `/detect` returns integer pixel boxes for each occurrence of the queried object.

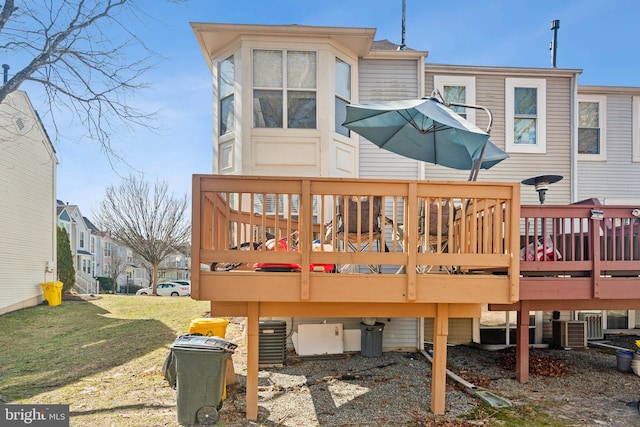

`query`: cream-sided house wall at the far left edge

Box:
[0,91,58,314]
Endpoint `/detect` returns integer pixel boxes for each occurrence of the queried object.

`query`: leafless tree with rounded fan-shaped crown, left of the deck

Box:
[96,175,191,294]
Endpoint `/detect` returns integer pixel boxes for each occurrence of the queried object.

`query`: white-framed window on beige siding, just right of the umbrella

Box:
[505,79,547,154]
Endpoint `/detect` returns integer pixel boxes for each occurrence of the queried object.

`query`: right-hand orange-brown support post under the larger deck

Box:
[431,303,449,415]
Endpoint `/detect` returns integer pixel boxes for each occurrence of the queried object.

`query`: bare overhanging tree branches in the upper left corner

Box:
[0,0,176,157]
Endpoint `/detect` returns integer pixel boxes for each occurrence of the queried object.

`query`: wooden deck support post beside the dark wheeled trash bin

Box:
[246,302,260,421]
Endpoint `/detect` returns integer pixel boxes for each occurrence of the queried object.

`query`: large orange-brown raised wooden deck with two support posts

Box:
[191,175,520,419]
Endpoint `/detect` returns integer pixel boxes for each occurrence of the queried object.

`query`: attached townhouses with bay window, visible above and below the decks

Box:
[192,23,640,349]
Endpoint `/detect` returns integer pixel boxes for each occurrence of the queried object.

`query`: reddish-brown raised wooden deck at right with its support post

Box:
[489,201,640,382]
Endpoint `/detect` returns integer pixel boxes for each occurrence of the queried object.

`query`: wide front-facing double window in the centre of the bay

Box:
[253,50,317,129]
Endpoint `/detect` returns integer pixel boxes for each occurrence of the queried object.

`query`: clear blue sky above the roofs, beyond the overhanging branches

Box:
[23,0,640,219]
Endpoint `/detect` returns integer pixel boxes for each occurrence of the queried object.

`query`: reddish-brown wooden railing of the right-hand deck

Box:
[520,204,640,300]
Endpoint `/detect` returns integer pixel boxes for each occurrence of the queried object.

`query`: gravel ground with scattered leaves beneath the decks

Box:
[212,319,640,427]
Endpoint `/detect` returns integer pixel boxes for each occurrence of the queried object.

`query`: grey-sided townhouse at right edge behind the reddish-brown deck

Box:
[575,86,640,336]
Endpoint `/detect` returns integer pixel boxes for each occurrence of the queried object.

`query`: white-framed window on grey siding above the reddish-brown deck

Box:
[578,96,607,160]
